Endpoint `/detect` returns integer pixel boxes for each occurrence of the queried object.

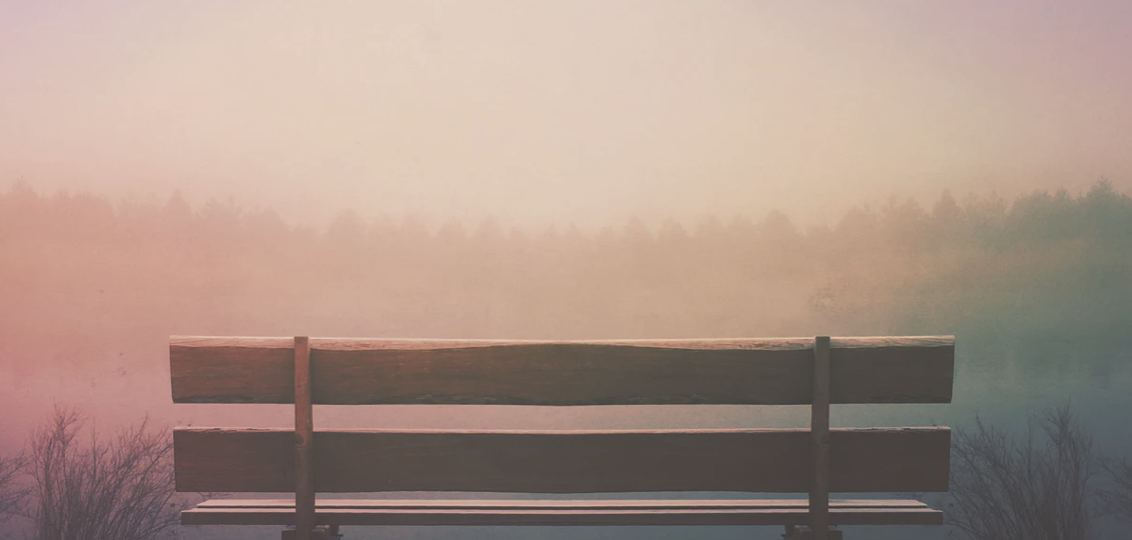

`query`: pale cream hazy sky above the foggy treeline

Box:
[0,0,1132,225]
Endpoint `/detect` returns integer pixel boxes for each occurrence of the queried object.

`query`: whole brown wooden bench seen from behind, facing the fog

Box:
[170,336,954,539]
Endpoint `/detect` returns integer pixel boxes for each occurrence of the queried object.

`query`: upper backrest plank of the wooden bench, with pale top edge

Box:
[170,336,954,405]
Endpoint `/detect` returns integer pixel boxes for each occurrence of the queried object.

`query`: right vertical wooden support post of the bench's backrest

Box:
[809,336,830,540]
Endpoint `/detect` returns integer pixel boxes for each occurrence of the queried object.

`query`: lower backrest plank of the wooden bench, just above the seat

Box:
[173,427,951,492]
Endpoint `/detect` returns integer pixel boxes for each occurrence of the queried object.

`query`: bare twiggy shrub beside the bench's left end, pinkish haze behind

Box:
[20,409,187,540]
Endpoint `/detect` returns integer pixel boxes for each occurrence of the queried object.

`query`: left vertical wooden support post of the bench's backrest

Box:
[294,336,315,540]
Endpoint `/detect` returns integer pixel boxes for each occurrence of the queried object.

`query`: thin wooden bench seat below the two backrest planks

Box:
[181,499,943,525]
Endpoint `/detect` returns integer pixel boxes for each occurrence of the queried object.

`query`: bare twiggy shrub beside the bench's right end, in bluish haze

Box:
[945,405,1099,540]
